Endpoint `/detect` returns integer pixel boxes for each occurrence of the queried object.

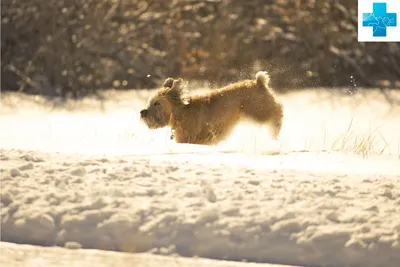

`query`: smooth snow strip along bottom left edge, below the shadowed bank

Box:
[0,242,293,267]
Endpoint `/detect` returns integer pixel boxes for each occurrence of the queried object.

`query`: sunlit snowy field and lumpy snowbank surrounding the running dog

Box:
[0,88,400,267]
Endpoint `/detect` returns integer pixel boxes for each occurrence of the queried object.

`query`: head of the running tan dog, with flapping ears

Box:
[140,78,185,129]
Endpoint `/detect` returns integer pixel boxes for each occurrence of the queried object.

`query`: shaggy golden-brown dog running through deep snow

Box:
[140,71,283,145]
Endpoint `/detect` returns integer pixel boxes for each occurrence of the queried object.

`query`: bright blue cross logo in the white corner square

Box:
[363,3,397,37]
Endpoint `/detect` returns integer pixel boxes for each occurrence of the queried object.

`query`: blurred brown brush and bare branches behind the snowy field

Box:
[1,0,400,97]
